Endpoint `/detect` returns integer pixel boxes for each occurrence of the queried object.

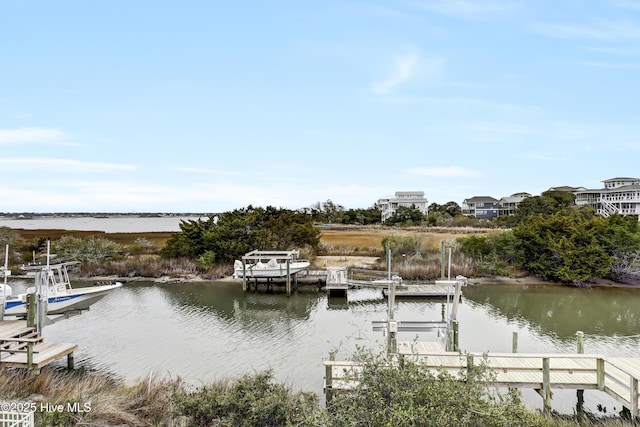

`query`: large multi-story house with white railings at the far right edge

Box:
[574,178,640,221]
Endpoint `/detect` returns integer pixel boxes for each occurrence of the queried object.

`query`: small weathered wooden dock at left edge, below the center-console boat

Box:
[0,320,78,370]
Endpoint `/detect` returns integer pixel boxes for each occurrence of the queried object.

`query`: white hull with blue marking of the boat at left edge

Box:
[4,282,122,317]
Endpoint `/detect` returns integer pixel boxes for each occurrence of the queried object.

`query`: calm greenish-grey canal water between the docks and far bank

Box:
[1,217,640,414]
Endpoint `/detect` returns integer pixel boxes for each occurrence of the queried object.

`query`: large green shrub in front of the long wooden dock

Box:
[327,352,550,427]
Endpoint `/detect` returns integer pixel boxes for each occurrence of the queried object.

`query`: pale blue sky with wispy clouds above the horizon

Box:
[0,0,640,212]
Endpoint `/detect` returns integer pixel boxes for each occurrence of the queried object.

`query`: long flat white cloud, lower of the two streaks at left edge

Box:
[0,157,135,176]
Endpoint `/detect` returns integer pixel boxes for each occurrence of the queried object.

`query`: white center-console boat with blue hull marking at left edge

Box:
[0,261,122,317]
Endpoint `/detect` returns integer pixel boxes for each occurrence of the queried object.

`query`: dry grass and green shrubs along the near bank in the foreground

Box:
[0,358,635,427]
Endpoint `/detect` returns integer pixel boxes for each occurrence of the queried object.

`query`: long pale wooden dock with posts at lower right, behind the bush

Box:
[324,343,640,416]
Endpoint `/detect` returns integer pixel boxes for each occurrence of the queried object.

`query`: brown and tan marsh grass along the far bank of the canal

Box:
[6,225,640,288]
